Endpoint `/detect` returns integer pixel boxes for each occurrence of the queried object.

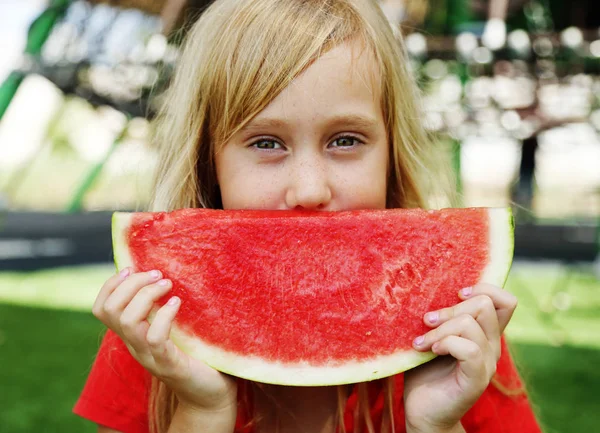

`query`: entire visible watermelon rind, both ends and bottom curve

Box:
[112,208,514,386]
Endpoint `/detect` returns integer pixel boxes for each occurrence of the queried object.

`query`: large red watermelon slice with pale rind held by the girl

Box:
[113,208,513,386]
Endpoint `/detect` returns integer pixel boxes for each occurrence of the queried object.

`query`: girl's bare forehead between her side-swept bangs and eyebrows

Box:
[255,40,381,119]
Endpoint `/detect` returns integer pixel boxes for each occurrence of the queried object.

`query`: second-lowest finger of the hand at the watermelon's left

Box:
[119,279,171,352]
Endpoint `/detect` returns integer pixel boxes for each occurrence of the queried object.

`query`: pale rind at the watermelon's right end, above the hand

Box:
[480,208,514,287]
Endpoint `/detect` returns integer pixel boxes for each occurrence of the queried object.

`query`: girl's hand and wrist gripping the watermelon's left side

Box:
[92,268,237,416]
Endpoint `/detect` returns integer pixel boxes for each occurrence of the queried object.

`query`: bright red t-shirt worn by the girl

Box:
[73,331,540,433]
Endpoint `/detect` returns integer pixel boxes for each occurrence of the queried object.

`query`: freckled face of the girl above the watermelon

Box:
[215,42,389,210]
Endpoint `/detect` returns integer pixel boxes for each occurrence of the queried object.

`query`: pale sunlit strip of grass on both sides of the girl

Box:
[0,263,600,348]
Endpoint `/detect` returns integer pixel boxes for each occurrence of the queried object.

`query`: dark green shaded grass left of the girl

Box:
[0,304,103,433]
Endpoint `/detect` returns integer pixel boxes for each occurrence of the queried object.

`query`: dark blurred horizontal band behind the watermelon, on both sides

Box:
[0,212,599,271]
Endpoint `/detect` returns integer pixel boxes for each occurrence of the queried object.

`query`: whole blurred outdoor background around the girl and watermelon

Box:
[0,0,600,433]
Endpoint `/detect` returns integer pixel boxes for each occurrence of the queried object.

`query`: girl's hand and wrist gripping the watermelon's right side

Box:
[404,284,517,433]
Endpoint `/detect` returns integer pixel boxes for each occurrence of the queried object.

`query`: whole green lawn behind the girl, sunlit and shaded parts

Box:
[0,265,600,433]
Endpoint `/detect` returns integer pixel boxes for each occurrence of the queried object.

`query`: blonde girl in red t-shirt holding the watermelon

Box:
[75,0,539,433]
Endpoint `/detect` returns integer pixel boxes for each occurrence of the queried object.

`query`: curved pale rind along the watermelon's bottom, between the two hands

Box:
[171,327,435,386]
